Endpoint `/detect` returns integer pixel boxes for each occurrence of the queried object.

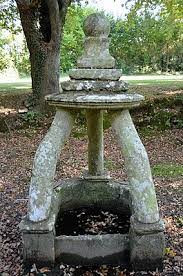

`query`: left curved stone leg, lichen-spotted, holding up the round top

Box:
[28,110,73,222]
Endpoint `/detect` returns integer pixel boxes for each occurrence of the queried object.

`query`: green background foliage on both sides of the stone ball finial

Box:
[61,3,183,73]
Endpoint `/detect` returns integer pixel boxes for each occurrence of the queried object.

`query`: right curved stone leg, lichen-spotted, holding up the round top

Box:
[112,110,159,223]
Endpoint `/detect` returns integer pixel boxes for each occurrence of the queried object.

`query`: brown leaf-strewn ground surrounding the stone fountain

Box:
[0,74,183,276]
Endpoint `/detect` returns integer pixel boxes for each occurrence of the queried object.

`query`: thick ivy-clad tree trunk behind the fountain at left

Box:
[16,0,71,111]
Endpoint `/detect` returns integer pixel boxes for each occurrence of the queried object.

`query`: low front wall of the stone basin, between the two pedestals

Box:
[55,234,129,265]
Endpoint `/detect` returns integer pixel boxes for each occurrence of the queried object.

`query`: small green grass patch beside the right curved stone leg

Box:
[152,164,183,177]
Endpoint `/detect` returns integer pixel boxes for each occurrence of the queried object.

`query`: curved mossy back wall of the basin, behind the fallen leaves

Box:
[55,179,131,214]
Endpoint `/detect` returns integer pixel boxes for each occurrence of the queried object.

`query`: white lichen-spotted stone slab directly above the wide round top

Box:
[61,80,128,93]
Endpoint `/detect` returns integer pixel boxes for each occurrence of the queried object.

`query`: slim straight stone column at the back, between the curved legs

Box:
[86,110,104,176]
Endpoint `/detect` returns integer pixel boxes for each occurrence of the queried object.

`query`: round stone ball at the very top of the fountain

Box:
[83,13,110,37]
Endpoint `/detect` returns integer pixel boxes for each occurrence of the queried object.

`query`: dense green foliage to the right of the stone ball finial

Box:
[111,12,183,73]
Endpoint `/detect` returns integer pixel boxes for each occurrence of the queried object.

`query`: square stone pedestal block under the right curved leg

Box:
[129,216,165,271]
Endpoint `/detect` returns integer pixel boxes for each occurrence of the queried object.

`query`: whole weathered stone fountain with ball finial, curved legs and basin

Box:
[20,14,164,270]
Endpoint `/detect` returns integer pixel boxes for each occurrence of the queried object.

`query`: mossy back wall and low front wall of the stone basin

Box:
[55,180,130,265]
